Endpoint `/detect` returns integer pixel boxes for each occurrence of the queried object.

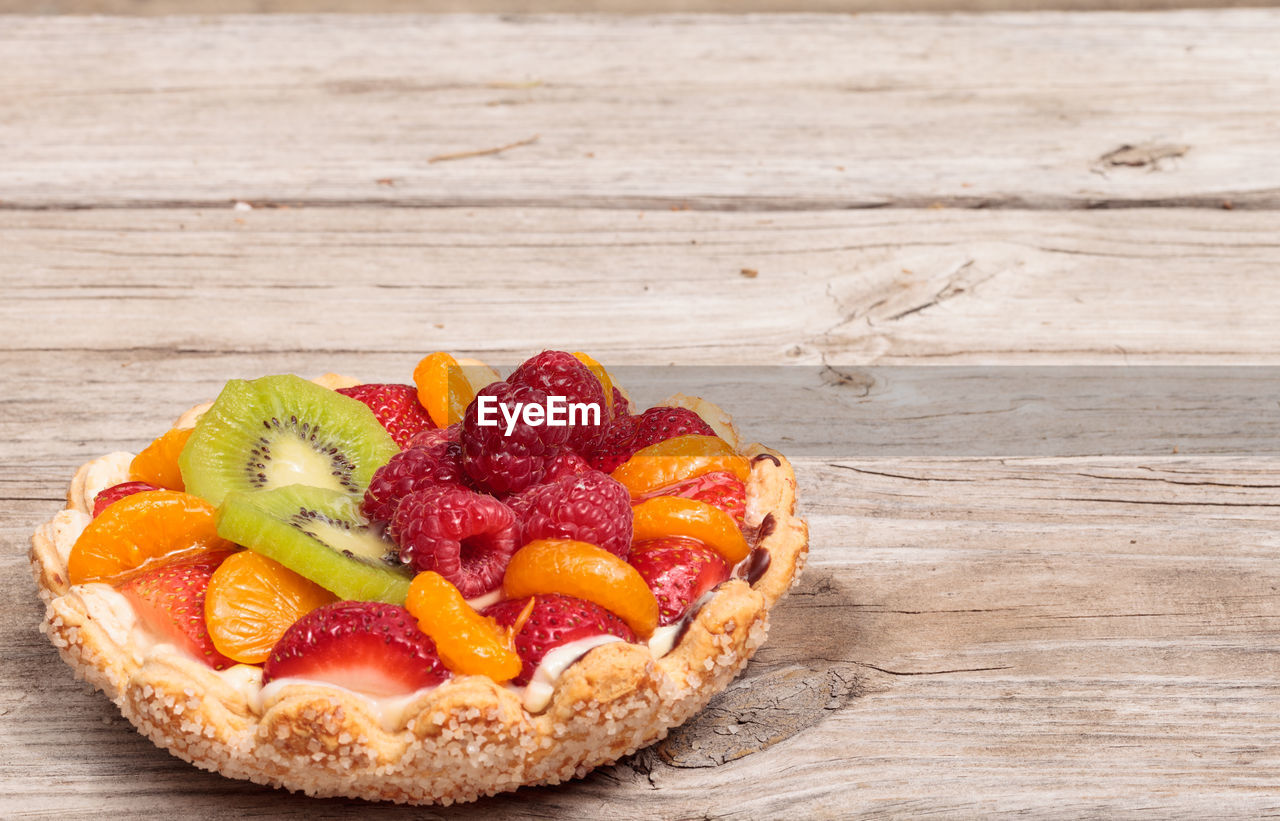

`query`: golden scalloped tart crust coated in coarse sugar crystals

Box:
[29,422,808,804]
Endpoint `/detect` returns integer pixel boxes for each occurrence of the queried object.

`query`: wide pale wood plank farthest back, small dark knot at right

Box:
[0,9,1280,210]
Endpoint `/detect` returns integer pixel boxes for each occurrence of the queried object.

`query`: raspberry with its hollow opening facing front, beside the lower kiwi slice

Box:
[390,484,520,598]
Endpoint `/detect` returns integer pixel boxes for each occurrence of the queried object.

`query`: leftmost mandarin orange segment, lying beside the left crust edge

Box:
[67,491,236,584]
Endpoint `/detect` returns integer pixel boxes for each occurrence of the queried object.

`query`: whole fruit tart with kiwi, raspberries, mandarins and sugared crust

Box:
[31,351,808,804]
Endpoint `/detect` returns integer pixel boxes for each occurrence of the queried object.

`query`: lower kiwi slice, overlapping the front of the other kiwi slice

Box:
[218,484,411,605]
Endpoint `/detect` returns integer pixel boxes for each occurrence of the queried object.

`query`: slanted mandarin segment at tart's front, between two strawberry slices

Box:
[404,570,524,684]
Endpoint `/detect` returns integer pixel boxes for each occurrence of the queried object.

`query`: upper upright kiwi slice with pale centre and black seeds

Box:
[178,374,399,505]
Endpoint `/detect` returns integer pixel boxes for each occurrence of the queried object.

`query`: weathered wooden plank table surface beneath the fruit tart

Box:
[0,10,1280,818]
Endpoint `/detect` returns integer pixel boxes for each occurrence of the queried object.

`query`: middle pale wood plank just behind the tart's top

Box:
[0,209,1280,363]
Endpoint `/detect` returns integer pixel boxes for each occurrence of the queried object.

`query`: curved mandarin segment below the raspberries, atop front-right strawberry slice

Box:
[502,539,658,638]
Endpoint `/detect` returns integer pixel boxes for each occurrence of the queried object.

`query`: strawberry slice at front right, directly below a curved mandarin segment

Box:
[484,593,636,687]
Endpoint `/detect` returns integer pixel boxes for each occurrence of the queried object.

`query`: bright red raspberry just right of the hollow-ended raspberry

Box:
[511,470,631,558]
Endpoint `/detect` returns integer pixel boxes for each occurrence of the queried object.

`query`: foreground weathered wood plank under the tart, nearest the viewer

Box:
[10,457,1280,818]
